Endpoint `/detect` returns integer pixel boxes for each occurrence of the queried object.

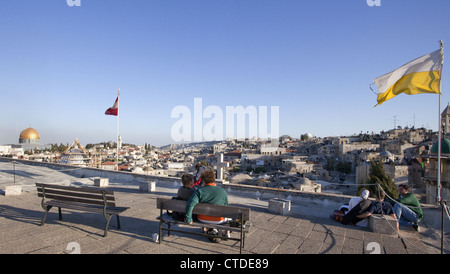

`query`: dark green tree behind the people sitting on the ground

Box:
[358,160,398,199]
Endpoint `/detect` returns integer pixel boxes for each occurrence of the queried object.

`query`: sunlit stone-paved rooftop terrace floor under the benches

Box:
[0,158,450,254]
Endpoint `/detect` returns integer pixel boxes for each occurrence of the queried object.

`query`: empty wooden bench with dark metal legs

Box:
[36,183,128,237]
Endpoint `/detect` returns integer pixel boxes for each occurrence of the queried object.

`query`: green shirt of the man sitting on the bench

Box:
[186,185,228,223]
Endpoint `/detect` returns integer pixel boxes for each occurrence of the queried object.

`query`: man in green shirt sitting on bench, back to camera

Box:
[186,170,230,238]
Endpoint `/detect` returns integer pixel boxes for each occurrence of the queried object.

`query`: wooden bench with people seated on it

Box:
[156,198,250,253]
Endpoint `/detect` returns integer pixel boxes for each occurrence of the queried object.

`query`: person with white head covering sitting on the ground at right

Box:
[341,188,372,227]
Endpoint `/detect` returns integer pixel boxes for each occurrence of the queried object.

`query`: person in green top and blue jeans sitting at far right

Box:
[394,184,423,231]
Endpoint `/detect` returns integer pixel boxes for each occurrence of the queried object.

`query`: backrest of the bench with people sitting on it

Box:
[156,198,250,221]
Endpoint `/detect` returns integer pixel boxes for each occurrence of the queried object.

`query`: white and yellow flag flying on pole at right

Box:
[374,44,444,106]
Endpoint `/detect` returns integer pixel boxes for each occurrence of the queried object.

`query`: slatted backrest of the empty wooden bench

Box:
[36,183,116,206]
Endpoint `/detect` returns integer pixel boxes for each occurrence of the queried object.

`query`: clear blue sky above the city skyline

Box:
[0,0,450,148]
